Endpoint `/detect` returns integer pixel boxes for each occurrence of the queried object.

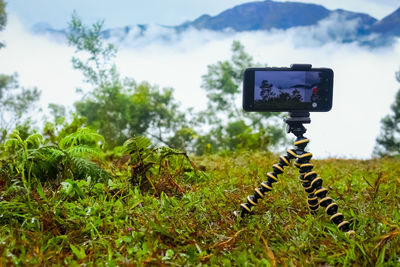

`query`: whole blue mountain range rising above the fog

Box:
[33,0,400,47]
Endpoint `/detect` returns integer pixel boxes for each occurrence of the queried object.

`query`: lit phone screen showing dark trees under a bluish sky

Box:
[254,71,326,108]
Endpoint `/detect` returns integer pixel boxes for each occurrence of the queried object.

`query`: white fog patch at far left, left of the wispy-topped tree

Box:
[0,16,81,111]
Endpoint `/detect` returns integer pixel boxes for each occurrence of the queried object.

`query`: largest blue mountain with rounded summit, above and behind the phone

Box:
[179,0,377,32]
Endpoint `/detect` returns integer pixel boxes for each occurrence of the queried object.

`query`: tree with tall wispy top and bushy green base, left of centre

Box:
[68,14,186,148]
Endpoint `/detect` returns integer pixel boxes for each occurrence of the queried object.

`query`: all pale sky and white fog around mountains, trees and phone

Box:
[0,0,400,158]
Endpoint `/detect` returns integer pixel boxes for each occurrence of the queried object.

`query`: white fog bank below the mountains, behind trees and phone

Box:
[0,16,400,158]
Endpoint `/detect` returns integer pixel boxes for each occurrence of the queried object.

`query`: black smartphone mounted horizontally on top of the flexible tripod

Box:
[243,68,333,112]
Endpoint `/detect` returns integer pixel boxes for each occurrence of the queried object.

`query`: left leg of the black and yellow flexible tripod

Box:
[234,149,297,217]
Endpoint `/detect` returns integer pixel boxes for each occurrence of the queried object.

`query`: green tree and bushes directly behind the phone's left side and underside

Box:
[195,41,285,154]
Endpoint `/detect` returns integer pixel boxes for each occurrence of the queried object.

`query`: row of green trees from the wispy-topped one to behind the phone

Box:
[40,14,284,155]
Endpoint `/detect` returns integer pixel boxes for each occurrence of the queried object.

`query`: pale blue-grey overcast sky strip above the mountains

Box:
[6,0,400,28]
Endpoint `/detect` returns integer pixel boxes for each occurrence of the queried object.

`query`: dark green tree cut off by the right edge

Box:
[374,70,400,156]
